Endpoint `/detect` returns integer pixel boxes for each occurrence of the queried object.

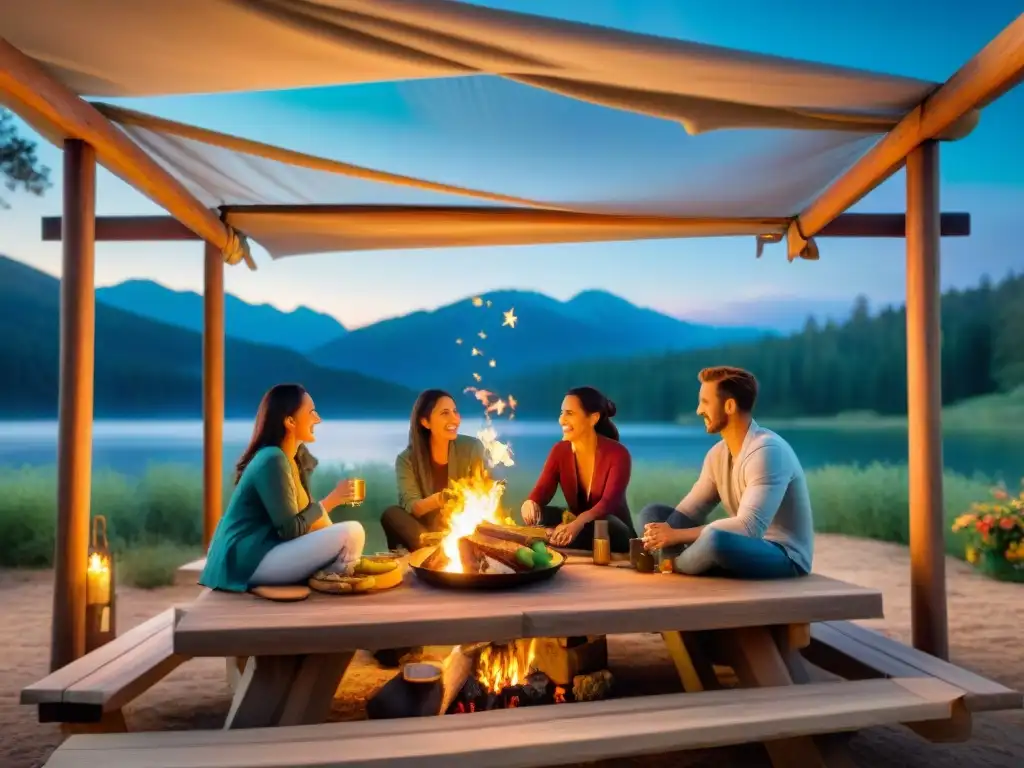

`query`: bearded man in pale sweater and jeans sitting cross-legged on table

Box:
[640,367,814,579]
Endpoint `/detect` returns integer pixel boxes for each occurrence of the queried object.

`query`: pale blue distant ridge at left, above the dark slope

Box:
[96,280,346,352]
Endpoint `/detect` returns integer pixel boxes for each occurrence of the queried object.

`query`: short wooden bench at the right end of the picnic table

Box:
[803,622,1024,713]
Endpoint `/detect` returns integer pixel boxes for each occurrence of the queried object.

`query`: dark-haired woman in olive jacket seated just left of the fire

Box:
[381,389,483,551]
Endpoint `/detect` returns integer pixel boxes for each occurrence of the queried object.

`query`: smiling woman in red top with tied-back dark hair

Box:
[521,387,637,552]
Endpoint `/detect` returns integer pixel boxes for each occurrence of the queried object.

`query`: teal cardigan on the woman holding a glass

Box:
[199,447,324,592]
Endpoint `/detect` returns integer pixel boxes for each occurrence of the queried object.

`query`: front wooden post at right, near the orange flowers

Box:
[906,141,949,659]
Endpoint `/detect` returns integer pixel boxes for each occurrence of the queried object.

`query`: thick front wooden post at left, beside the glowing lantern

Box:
[50,139,96,671]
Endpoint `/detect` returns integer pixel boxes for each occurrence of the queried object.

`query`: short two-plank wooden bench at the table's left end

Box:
[22,608,185,732]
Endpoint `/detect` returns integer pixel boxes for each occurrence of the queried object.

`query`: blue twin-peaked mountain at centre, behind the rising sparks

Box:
[309,291,765,388]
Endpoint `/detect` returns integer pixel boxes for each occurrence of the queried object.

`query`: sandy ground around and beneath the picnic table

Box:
[0,536,1024,768]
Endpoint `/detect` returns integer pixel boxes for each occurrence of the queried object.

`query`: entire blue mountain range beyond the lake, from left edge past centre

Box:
[0,256,767,418]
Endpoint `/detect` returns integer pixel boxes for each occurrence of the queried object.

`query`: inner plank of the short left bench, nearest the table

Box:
[63,625,186,710]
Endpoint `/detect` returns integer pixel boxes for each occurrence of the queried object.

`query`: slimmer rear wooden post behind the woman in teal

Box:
[203,243,224,552]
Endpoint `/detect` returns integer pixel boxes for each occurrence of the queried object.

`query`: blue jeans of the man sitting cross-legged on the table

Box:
[640,504,803,579]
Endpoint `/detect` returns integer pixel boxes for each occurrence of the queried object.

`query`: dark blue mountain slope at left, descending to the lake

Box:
[0,256,416,418]
